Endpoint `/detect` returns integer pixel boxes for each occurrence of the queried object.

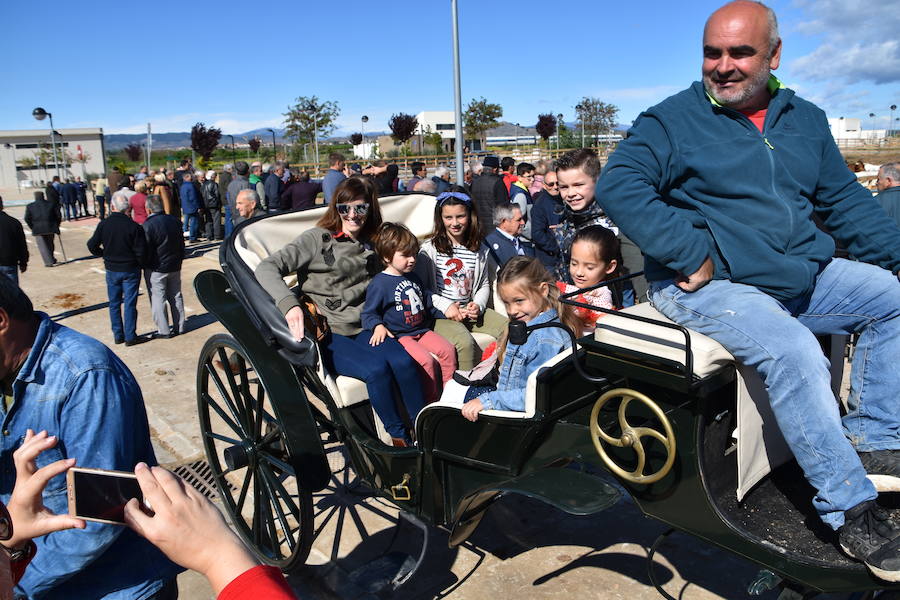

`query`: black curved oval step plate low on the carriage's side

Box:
[500,467,621,515]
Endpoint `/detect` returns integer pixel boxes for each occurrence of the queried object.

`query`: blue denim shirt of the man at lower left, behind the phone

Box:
[0,313,183,600]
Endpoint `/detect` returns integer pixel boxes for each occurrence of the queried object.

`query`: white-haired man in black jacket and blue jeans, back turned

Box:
[87,191,147,346]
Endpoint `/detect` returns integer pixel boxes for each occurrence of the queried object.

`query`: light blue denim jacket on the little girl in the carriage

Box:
[478,308,571,412]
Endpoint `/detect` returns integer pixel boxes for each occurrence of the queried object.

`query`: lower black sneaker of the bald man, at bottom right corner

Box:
[838,500,900,581]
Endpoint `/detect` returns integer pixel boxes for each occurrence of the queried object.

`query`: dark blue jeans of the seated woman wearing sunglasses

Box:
[322,330,425,438]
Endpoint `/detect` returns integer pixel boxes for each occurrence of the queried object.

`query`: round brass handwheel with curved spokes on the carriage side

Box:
[590,388,675,484]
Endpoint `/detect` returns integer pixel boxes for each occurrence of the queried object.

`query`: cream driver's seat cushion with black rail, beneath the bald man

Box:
[594,302,734,378]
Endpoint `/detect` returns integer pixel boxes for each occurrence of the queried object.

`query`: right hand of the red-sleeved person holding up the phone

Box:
[125,463,259,594]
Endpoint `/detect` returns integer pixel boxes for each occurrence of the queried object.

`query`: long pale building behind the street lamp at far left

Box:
[0,127,106,189]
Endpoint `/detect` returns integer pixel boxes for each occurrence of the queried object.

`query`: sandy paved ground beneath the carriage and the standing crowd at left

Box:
[0,195,872,600]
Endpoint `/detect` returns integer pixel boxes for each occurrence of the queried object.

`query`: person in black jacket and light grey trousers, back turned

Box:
[144,196,186,339]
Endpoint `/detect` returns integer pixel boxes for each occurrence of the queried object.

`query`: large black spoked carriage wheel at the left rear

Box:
[197,334,313,571]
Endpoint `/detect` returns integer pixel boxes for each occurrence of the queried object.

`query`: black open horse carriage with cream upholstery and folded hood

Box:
[194,194,900,600]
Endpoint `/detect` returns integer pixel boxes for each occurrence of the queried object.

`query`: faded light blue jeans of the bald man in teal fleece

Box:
[650,259,900,529]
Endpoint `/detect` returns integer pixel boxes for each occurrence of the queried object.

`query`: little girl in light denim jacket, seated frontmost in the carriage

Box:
[462,256,581,421]
